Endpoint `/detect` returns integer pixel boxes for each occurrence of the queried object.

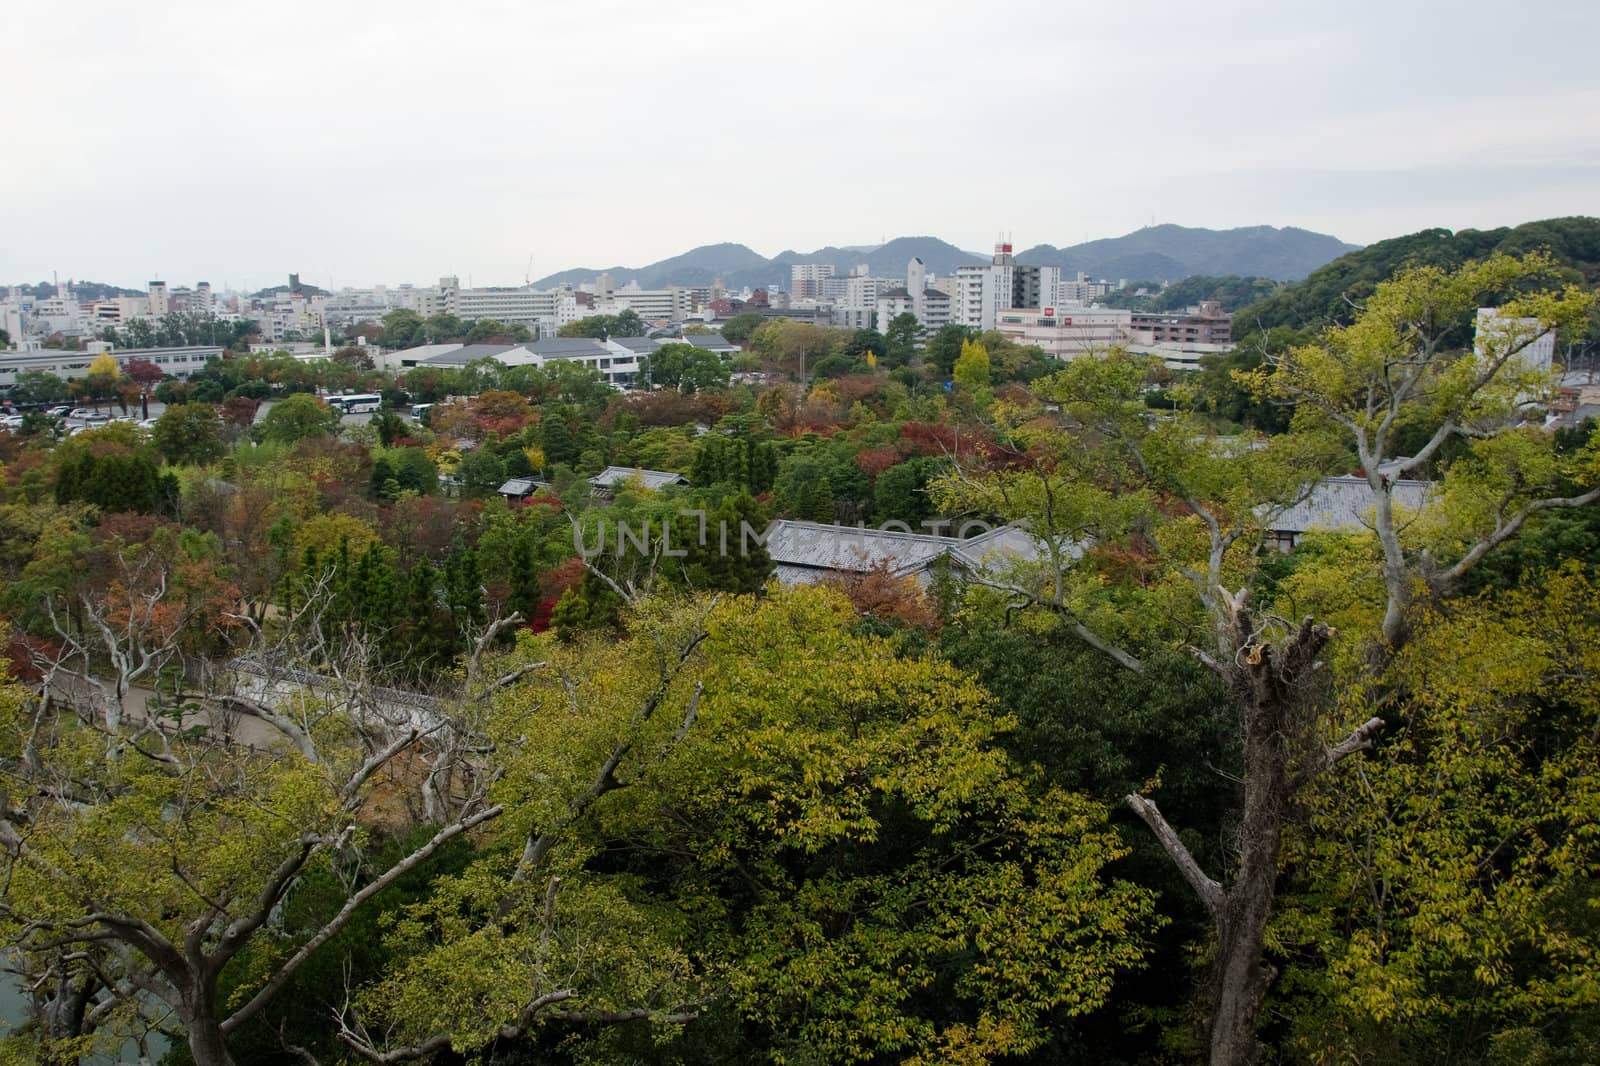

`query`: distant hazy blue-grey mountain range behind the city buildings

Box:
[534,226,1360,288]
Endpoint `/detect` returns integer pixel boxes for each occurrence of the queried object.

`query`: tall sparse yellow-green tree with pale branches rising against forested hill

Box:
[1253,253,1600,645]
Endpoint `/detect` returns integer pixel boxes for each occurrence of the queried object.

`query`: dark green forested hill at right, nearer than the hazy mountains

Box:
[1235,216,1600,330]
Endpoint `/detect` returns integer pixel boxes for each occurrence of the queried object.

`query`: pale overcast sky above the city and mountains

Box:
[0,0,1600,288]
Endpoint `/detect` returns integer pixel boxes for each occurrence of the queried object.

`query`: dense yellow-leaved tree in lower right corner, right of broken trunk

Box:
[1275,563,1600,1066]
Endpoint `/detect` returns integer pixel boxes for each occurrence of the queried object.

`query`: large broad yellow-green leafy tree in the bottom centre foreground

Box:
[344,589,1150,1063]
